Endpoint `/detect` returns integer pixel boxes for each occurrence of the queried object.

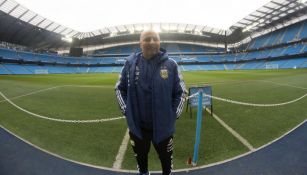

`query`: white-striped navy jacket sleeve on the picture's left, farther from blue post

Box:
[115,61,128,115]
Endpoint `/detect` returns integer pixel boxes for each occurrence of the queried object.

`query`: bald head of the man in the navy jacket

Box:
[140,30,160,59]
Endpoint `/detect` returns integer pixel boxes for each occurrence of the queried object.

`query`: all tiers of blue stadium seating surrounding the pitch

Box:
[0,20,307,74]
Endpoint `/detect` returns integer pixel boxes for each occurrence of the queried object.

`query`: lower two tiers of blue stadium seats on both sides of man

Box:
[0,40,307,74]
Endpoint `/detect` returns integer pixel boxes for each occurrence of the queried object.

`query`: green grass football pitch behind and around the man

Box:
[0,69,307,170]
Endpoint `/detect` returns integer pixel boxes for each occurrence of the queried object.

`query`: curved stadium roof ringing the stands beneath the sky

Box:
[0,0,307,48]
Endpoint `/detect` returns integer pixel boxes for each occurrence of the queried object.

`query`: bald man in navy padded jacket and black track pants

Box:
[115,30,186,175]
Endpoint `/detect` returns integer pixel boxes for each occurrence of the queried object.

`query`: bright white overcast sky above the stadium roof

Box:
[15,0,270,32]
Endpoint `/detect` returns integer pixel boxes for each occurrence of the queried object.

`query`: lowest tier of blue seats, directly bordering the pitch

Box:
[0,58,307,74]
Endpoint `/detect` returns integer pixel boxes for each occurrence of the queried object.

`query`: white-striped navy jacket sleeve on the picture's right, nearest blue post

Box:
[172,64,187,119]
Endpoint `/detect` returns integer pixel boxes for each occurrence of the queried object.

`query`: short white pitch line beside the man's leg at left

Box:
[112,129,130,170]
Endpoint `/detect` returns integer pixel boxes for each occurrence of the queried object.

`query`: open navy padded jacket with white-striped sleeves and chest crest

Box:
[115,52,186,144]
